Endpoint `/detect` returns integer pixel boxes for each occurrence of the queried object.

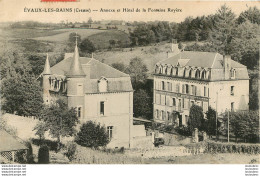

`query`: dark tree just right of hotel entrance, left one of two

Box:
[188,105,204,131]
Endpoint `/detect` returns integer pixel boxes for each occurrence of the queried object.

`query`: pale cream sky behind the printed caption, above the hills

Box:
[0,0,260,23]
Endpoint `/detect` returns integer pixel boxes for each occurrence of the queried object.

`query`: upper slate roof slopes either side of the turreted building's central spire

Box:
[51,53,129,79]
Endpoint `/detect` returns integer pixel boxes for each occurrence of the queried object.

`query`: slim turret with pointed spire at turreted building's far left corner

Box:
[42,53,51,104]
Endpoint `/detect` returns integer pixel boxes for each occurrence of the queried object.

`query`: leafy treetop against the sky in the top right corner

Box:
[237,6,260,24]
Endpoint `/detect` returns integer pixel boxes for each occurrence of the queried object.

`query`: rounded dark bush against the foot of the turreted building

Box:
[75,121,109,148]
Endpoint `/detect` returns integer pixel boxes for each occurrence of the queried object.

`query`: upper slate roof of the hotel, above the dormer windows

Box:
[158,51,246,68]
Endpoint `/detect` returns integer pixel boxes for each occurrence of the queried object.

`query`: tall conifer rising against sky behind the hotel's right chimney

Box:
[211,5,235,54]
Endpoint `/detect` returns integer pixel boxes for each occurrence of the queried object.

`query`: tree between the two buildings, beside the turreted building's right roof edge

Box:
[126,57,148,89]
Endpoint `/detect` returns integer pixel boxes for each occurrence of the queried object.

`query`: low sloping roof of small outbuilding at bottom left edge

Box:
[0,130,28,152]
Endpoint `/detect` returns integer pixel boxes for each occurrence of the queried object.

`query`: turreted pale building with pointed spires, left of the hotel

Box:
[40,45,133,147]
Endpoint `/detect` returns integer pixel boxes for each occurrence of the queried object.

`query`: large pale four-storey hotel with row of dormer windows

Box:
[153,51,249,126]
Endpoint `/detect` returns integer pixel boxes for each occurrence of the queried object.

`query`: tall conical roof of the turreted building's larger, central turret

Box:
[67,40,85,77]
